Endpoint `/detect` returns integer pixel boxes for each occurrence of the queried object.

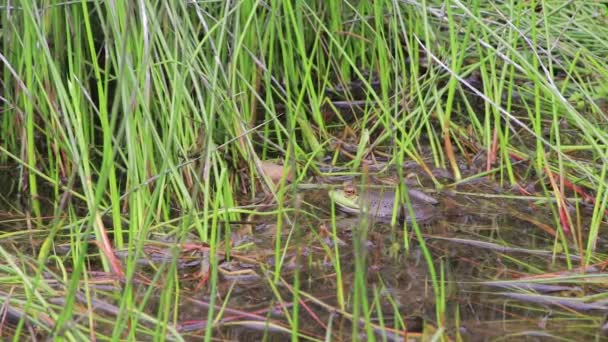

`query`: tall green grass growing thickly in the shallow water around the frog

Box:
[0,0,608,340]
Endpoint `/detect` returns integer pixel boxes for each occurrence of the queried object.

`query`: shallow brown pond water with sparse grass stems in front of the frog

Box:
[2,168,608,341]
